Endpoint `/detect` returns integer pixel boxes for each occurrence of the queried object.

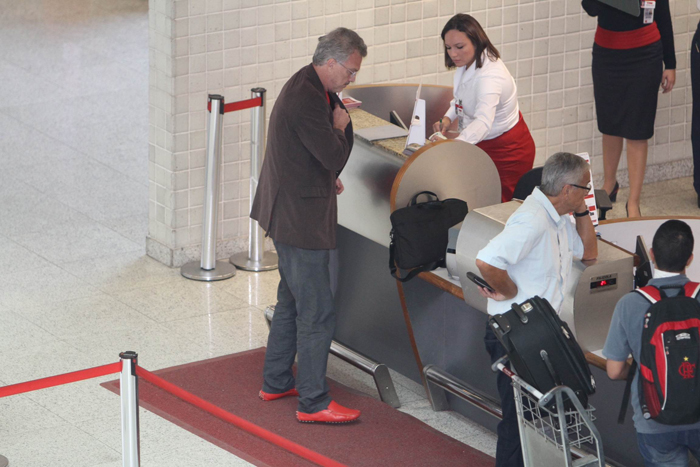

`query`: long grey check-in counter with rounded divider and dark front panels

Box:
[332,85,639,465]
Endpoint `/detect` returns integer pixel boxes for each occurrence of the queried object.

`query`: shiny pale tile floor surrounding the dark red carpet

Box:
[0,0,495,467]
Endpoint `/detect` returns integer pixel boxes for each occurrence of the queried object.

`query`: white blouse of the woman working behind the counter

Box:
[445,51,520,144]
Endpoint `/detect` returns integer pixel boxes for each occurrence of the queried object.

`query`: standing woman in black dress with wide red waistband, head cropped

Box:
[582,0,676,217]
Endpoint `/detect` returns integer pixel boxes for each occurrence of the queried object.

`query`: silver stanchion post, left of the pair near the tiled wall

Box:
[180,94,236,281]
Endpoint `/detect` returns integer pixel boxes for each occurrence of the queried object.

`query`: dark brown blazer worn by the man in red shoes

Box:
[250,65,353,250]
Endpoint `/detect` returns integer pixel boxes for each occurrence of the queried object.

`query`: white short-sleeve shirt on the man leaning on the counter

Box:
[476,188,583,315]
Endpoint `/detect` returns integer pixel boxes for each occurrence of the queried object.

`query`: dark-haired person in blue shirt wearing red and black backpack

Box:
[603,220,700,467]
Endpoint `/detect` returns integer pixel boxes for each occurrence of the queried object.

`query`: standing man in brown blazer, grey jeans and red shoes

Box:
[250,28,367,423]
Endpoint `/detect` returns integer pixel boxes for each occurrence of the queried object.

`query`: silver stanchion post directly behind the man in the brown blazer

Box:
[230,88,277,271]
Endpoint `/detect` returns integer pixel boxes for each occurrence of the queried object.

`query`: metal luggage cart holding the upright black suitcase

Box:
[493,357,606,467]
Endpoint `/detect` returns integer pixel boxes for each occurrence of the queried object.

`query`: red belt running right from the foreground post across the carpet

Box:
[136,365,346,467]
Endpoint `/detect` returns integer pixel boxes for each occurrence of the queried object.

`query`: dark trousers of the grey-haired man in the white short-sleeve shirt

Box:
[484,324,524,467]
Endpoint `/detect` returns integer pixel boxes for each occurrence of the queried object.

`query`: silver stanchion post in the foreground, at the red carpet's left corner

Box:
[119,350,140,467]
